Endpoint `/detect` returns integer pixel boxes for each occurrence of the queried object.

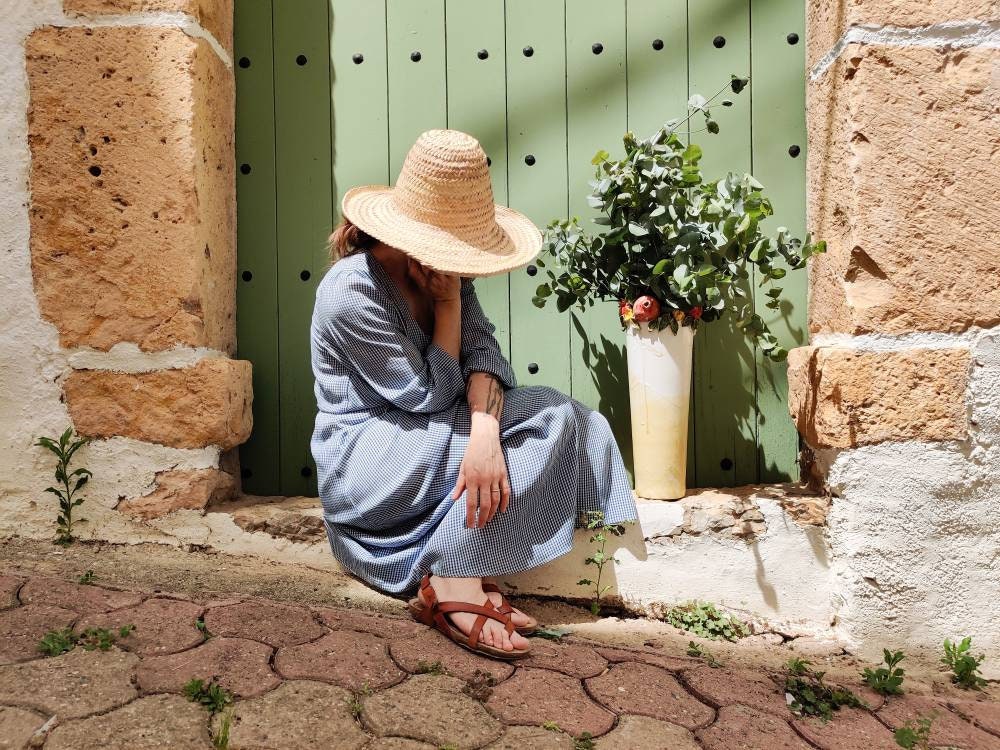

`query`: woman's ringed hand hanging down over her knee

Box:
[451,412,510,529]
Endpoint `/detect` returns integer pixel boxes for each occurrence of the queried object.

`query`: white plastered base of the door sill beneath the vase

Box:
[505,497,834,633]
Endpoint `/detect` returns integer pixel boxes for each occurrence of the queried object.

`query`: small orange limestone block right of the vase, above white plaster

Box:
[788,346,970,448]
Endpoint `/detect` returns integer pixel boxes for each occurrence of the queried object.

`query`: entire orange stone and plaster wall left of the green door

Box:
[0,0,252,542]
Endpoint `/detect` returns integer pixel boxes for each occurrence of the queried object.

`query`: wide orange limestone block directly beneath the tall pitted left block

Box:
[63,359,253,448]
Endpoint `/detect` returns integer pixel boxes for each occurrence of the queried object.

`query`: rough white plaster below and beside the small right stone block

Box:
[828,331,1000,677]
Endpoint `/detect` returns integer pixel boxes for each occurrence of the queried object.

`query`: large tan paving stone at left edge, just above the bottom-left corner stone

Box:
[0,648,139,720]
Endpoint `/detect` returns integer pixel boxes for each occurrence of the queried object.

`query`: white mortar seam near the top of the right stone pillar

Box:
[809,19,1000,81]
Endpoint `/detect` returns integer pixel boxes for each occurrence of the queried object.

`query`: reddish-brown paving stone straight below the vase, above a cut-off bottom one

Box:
[586,662,715,729]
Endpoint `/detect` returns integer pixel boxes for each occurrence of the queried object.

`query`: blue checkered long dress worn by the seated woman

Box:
[311,253,636,594]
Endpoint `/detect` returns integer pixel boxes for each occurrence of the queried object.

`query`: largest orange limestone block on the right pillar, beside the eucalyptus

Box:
[807,45,1000,334]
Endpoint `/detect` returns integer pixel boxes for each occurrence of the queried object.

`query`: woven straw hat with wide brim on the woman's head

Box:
[341,130,542,276]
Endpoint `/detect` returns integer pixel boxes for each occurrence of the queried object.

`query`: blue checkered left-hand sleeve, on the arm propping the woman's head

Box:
[314,275,465,414]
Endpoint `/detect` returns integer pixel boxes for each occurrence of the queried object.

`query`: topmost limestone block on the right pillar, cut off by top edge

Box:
[806,0,1000,67]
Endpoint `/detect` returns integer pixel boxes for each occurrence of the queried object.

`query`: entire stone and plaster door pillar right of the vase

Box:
[789,0,1000,669]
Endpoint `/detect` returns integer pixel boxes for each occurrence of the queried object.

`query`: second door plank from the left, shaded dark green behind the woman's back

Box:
[273,0,332,495]
